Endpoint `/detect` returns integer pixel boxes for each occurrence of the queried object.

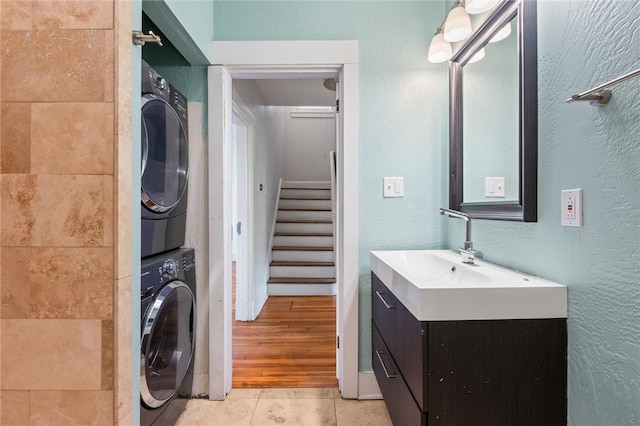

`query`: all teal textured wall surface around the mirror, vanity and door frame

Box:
[162,0,640,425]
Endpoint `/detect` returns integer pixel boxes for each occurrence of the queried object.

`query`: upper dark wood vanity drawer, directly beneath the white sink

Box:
[371,273,429,411]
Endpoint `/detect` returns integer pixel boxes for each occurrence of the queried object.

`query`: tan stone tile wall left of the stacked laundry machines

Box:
[0,0,132,425]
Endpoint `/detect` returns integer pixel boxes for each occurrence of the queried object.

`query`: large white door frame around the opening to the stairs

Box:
[208,40,359,400]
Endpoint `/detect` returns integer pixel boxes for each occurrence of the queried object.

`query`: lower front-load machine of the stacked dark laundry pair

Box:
[140,248,196,426]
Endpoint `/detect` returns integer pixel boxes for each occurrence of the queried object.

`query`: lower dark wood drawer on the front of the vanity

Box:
[371,323,427,426]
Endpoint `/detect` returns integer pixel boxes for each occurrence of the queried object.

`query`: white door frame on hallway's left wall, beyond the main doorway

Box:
[233,94,256,321]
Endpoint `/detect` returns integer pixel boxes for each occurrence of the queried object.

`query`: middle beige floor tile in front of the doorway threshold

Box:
[251,399,336,426]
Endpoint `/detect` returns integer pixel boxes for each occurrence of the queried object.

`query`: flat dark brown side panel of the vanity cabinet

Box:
[429,319,567,426]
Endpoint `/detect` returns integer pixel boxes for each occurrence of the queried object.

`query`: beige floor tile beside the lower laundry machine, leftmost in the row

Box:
[176,398,258,426]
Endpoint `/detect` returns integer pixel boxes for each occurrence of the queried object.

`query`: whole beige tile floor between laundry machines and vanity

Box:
[176,388,391,426]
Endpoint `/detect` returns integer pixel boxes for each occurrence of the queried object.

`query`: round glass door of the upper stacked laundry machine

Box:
[141,95,189,213]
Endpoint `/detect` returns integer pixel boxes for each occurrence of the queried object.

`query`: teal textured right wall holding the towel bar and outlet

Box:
[442,0,640,426]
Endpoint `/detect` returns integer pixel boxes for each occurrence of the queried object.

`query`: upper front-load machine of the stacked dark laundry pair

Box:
[141,61,189,258]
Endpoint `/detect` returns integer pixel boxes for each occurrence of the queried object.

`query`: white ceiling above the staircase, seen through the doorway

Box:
[255,79,336,106]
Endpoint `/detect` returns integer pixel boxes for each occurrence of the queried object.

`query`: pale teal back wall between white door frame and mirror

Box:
[214,1,448,371]
